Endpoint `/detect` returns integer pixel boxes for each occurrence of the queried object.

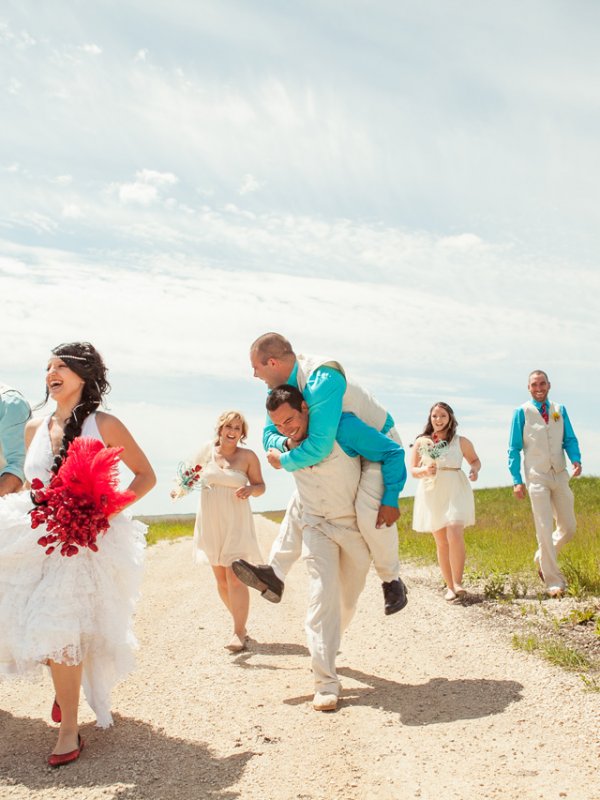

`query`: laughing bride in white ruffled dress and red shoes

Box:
[0,342,156,767]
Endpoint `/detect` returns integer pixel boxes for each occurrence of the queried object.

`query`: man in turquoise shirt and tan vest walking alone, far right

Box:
[508,369,581,597]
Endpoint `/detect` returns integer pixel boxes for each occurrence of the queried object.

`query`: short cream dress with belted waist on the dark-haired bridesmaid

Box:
[412,436,475,533]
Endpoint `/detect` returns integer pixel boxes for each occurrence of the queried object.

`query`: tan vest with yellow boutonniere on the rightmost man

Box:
[521,401,567,480]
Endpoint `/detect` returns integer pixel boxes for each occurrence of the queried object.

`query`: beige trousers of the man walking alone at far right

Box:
[527,469,577,589]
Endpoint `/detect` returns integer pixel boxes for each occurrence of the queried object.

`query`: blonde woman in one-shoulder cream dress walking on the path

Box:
[189,411,265,653]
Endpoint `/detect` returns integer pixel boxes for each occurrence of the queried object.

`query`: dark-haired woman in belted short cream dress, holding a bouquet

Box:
[410,403,481,601]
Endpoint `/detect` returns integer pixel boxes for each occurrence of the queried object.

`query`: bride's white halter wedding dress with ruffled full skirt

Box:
[0,414,146,728]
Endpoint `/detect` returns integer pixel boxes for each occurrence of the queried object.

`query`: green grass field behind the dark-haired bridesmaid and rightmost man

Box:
[398,478,600,597]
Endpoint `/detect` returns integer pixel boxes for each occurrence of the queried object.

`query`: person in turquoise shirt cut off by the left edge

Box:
[0,383,31,497]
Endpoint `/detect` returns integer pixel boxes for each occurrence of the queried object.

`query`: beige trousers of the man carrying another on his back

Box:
[303,515,370,695]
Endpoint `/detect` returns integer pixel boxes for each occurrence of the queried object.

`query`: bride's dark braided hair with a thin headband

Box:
[46,342,110,474]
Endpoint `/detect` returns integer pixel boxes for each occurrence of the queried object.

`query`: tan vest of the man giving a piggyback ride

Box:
[292,442,360,527]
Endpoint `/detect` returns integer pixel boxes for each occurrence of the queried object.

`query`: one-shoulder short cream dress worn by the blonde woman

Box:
[194,448,263,567]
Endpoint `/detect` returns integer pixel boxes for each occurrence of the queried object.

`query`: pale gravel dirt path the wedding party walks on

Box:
[0,517,600,800]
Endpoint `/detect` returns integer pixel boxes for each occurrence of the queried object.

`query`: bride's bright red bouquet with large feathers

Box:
[30,436,135,556]
